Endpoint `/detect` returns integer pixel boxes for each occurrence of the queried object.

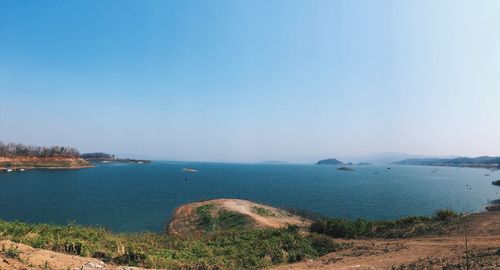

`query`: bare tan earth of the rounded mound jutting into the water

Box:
[167,199,311,235]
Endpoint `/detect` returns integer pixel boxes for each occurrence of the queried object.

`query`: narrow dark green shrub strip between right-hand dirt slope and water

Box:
[310,209,460,238]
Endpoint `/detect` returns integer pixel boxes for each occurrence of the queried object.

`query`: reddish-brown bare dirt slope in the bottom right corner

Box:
[273,212,500,270]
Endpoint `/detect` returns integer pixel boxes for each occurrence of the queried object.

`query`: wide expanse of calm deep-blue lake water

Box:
[0,161,500,232]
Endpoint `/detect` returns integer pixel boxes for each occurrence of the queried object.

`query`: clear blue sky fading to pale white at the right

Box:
[0,0,500,162]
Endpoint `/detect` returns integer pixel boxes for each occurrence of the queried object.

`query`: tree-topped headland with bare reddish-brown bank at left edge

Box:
[0,142,93,172]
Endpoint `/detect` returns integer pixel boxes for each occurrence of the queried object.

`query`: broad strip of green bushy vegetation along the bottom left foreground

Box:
[0,221,342,269]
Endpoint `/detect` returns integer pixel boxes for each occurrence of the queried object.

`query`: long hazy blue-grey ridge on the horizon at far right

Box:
[393,156,500,169]
